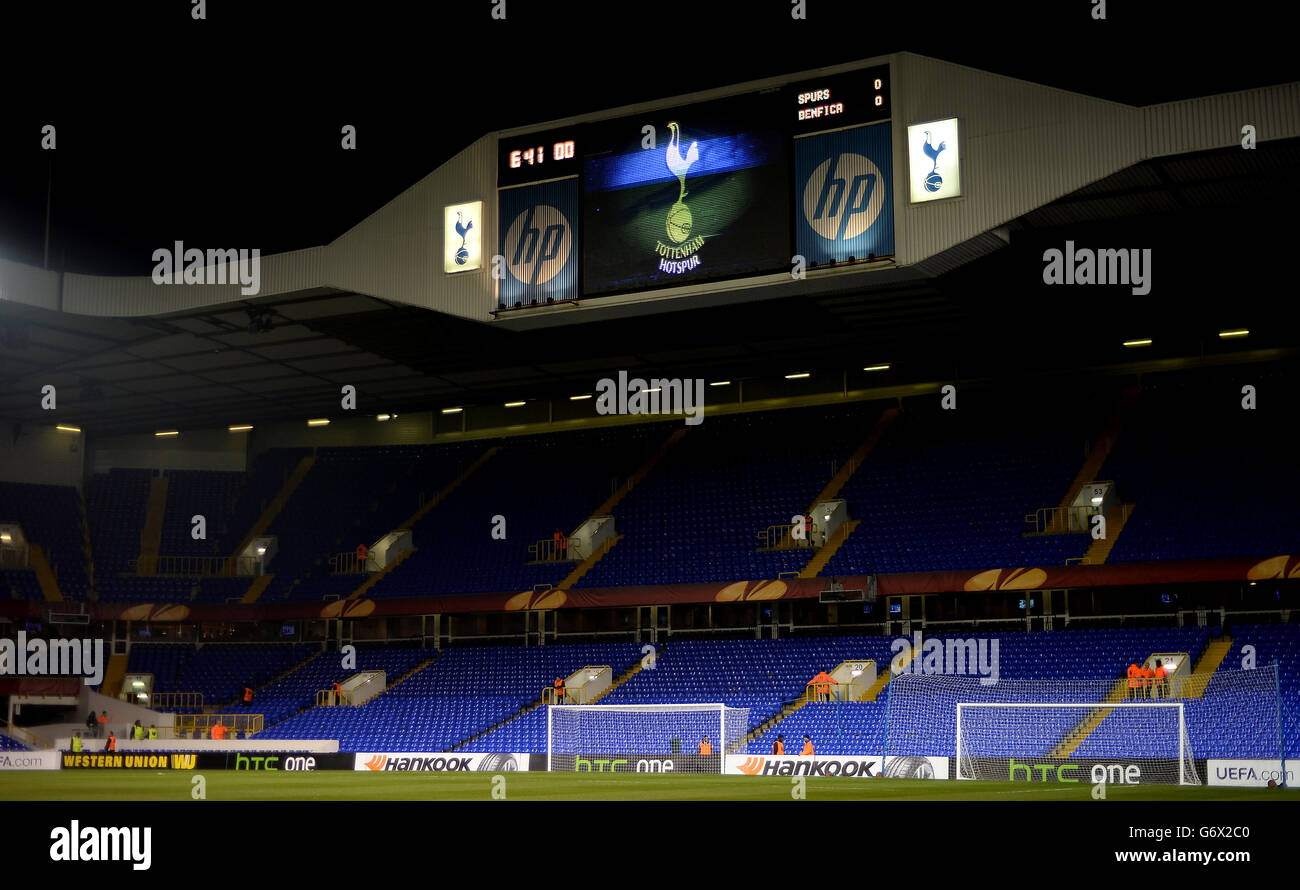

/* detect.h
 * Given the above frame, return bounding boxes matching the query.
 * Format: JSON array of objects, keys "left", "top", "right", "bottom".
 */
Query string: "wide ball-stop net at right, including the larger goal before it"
[{"left": 884, "top": 665, "right": 1281, "bottom": 785}]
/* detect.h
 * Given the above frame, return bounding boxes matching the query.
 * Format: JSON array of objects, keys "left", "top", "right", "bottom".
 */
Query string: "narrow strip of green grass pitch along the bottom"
[{"left": 0, "top": 770, "right": 1300, "bottom": 803}]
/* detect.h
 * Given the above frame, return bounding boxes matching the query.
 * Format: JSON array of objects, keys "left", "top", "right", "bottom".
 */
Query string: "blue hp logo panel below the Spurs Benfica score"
[{"left": 794, "top": 123, "right": 894, "bottom": 265}]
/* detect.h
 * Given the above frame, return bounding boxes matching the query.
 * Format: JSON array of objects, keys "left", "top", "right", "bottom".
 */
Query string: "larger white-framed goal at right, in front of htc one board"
[{"left": 956, "top": 702, "right": 1201, "bottom": 785}]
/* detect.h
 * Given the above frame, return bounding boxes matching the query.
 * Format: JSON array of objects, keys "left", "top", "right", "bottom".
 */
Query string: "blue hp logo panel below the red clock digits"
[{"left": 497, "top": 178, "right": 579, "bottom": 307}]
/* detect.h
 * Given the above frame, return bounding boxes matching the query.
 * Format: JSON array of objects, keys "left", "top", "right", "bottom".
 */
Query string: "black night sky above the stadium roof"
[{"left": 0, "top": 0, "right": 1300, "bottom": 274}]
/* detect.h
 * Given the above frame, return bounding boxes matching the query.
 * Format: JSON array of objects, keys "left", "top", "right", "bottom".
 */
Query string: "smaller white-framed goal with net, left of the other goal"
[{"left": 546, "top": 704, "right": 749, "bottom": 773}]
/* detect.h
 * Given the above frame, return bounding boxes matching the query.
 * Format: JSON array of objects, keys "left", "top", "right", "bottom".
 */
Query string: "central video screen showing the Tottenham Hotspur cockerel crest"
[{"left": 582, "top": 92, "right": 790, "bottom": 296}]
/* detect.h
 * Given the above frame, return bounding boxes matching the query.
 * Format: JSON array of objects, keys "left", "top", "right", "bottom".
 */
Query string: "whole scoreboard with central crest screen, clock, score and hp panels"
[{"left": 497, "top": 65, "right": 893, "bottom": 308}]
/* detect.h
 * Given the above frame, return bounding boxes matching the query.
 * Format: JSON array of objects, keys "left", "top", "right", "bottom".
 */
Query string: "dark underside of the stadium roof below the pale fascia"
[{"left": 0, "top": 133, "right": 1300, "bottom": 431}]
